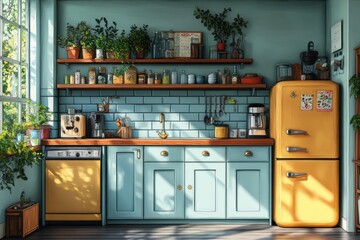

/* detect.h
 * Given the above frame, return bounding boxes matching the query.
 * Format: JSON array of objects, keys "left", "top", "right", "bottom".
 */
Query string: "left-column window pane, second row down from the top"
[{"left": 2, "top": 23, "right": 19, "bottom": 60}]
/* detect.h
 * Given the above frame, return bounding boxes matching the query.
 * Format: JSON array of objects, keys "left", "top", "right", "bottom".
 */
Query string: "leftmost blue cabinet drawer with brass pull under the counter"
[{"left": 144, "top": 146, "right": 184, "bottom": 162}]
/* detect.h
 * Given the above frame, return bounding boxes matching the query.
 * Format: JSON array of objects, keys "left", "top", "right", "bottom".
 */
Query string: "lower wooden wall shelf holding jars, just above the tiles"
[{"left": 56, "top": 83, "right": 266, "bottom": 90}]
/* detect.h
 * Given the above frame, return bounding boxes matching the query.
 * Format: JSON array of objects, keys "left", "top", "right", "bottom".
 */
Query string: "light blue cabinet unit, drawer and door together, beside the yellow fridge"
[{"left": 226, "top": 146, "right": 271, "bottom": 219}]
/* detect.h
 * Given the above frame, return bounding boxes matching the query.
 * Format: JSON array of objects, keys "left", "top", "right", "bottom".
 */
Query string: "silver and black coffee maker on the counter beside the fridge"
[{"left": 247, "top": 103, "right": 267, "bottom": 138}]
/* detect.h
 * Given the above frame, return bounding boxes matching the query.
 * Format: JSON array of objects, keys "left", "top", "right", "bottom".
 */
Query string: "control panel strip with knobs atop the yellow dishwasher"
[{"left": 46, "top": 148, "right": 101, "bottom": 159}]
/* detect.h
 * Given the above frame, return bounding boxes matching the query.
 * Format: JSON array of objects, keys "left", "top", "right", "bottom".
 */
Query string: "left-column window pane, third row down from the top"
[{"left": 2, "top": 61, "right": 19, "bottom": 97}]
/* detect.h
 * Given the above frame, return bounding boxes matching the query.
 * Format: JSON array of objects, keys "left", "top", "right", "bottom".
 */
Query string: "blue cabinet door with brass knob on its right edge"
[{"left": 144, "top": 163, "right": 184, "bottom": 219}]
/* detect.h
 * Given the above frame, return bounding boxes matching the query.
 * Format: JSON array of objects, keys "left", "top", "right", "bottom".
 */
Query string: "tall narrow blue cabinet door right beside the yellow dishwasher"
[{"left": 107, "top": 146, "right": 143, "bottom": 219}]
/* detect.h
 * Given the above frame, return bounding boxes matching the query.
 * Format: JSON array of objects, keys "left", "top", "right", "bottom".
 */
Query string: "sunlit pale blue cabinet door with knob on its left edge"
[{"left": 185, "top": 162, "right": 225, "bottom": 219}]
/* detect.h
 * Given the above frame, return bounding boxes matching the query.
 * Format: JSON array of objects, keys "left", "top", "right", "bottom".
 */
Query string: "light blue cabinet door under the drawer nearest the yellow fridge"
[{"left": 227, "top": 162, "right": 270, "bottom": 219}]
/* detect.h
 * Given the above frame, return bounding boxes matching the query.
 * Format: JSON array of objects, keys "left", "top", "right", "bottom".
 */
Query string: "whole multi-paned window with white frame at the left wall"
[{"left": 0, "top": 0, "right": 30, "bottom": 132}]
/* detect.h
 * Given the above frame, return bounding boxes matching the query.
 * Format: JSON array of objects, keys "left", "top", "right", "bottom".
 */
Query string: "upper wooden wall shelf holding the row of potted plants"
[{"left": 57, "top": 58, "right": 253, "bottom": 64}]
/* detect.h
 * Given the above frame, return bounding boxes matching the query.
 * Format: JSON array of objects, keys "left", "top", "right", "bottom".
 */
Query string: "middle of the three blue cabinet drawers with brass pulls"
[{"left": 185, "top": 146, "right": 225, "bottom": 162}]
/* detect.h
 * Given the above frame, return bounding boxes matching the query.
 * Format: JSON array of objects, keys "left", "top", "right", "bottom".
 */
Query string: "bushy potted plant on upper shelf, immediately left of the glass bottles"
[{"left": 129, "top": 24, "right": 151, "bottom": 58}]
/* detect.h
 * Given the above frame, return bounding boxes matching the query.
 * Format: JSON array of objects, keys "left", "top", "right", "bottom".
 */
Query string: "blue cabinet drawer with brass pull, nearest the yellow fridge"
[{"left": 226, "top": 146, "right": 271, "bottom": 162}]
